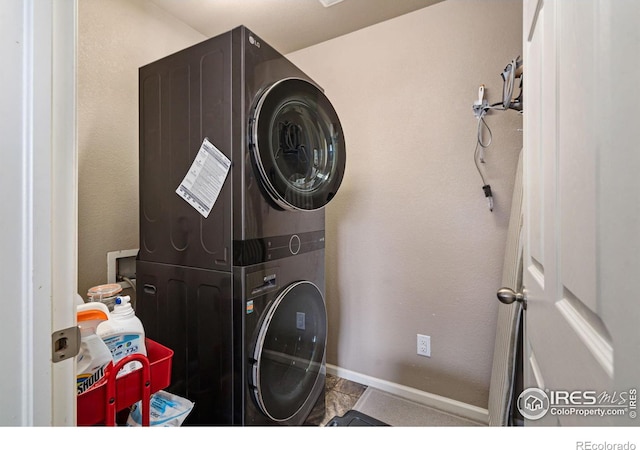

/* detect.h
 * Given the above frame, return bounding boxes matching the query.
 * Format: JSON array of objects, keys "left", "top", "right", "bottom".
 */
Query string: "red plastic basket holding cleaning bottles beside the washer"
[{"left": 77, "top": 338, "right": 173, "bottom": 426}]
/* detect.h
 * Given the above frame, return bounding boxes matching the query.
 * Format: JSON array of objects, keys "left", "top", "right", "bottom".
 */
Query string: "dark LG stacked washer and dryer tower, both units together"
[{"left": 136, "top": 27, "right": 345, "bottom": 425}]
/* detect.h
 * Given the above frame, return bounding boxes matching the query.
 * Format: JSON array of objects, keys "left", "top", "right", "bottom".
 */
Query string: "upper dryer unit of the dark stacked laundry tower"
[{"left": 139, "top": 27, "right": 346, "bottom": 271}]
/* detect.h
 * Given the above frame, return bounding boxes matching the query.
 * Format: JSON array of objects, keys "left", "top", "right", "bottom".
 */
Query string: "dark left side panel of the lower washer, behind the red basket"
[{"left": 136, "top": 261, "right": 234, "bottom": 425}]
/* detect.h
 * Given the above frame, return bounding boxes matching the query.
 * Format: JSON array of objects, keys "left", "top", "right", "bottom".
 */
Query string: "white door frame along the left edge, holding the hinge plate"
[{"left": 0, "top": 0, "right": 77, "bottom": 426}]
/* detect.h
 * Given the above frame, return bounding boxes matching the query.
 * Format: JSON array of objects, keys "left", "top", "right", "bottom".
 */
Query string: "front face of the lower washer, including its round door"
[{"left": 236, "top": 250, "right": 327, "bottom": 425}]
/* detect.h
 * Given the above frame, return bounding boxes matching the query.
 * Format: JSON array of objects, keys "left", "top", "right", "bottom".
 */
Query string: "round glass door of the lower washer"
[{"left": 251, "top": 281, "right": 327, "bottom": 422}]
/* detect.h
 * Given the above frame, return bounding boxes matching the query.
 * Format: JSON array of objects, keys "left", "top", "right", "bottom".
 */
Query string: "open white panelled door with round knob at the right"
[{"left": 519, "top": 0, "right": 640, "bottom": 426}]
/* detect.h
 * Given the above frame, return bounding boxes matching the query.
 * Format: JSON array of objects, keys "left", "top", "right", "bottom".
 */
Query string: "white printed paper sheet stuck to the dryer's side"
[{"left": 176, "top": 138, "right": 231, "bottom": 218}]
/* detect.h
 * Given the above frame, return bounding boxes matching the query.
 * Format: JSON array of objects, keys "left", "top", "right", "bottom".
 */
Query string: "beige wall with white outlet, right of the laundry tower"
[{"left": 288, "top": 0, "right": 522, "bottom": 408}]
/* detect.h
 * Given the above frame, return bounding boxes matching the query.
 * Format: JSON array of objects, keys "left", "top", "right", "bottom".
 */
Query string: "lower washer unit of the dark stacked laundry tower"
[{"left": 136, "top": 245, "right": 327, "bottom": 426}]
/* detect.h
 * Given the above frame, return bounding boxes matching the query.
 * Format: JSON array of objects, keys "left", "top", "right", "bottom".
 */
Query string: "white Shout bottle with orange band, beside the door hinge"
[{"left": 76, "top": 303, "right": 113, "bottom": 395}]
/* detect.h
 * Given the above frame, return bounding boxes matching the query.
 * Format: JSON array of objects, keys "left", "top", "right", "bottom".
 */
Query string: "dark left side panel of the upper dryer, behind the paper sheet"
[{"left": 139, "top": 34, "right": 233, "bottom": 270}]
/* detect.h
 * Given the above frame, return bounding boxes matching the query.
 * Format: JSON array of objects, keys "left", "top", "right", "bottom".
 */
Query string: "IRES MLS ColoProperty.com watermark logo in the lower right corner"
[{"left": 517, "top": 388, "right": 637, "bottom": 420}]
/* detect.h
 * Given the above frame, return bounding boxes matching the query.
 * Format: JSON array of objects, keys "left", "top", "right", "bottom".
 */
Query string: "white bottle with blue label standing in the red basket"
[{"left": 97, "top": 295, "right": 147, "bottom": 377}]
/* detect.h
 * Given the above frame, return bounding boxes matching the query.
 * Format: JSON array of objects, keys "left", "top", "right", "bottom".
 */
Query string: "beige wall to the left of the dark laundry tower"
[{"left": 77, "top": 0, "right": 206, "bottom": 297}]
